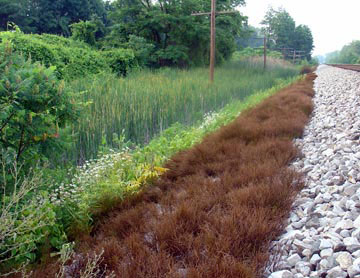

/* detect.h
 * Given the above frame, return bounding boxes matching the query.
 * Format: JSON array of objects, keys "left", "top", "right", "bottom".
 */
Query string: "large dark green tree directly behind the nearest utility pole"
[{"left": 106, "top": 0, "right": 245, "bottom": 66}]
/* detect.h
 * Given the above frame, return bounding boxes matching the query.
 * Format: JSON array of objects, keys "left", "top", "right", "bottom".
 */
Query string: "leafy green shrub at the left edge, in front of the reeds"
[{"left": 0, "top": 41, "right": 78, "bottom": 164}]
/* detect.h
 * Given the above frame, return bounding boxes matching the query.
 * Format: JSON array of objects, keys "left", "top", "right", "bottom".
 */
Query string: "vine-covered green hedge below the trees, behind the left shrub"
[{"left": 0, "top": 32, "right": 138, "bottom": 80}]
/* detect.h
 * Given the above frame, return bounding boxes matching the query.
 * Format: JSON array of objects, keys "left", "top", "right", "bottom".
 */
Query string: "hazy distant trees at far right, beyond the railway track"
[{"left": 326, "top": 41, "right": 360, "bottom": 64}]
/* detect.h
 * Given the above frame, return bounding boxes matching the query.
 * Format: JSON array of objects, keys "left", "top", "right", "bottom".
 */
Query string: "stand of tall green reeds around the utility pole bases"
[{"left": 71, "top": 59, "right": 297, "bottom": 161}]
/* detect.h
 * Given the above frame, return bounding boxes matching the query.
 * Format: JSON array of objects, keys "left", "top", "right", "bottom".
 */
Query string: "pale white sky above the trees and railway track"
[{"left": 239, "top": 0, "right": 360, "bottom": 55}]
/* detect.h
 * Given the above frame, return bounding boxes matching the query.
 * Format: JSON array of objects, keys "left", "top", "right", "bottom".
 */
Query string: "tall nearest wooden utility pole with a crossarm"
[{"left": 191, "top": 0, "right": 237, "bottom": 83}]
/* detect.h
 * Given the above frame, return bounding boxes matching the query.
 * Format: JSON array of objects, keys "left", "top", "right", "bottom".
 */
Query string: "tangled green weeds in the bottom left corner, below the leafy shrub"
[{"left": 0, "top": 156, "right": 67, "bottom": 274}]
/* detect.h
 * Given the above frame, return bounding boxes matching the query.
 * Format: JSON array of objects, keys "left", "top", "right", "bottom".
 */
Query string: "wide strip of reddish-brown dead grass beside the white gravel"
[{"left": 34, "top": 74, "right": 315, "bottom": 278}]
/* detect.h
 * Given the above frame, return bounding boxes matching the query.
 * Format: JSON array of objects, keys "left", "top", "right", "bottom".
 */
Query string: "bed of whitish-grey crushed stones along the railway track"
[{"left": 265, "top": 66, "right": 360, "bottom": 278}]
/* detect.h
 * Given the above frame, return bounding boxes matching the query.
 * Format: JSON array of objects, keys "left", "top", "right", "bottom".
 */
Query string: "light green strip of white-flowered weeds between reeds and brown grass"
[{"left": 58, "top": 73, "right": 297, "bottom": 230}]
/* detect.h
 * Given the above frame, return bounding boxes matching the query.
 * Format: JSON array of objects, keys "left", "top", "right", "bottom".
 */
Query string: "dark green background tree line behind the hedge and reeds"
[{"left": 0, "top": 0, "right": 313, "bottom": 67}]
